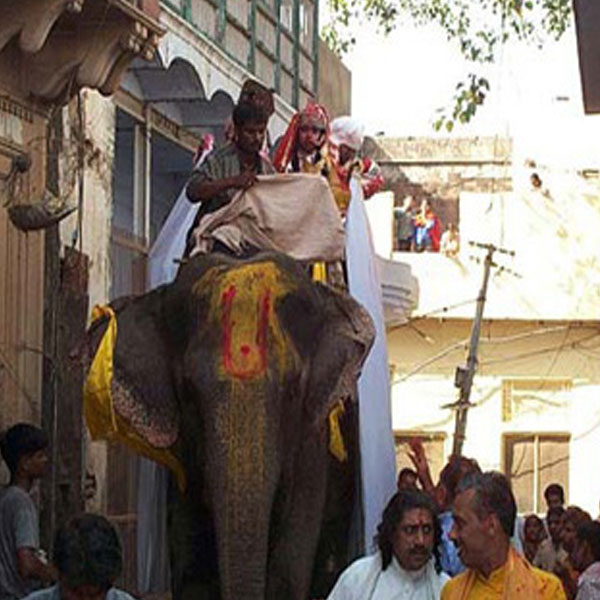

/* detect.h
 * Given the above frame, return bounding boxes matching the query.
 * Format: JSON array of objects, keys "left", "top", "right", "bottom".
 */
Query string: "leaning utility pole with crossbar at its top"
[{"left": 452, "top": 242, "right": 515, "bottom": 454}]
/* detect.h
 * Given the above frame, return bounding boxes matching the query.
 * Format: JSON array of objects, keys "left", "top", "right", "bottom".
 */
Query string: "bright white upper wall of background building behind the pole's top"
[{"left": 377, "top": 152, "right": 600, "bottom": 320}]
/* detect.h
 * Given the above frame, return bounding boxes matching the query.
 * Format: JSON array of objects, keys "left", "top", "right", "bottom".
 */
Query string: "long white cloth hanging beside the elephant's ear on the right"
[{"left": 346, "top": 178, "right": 396, "bottom": 551}]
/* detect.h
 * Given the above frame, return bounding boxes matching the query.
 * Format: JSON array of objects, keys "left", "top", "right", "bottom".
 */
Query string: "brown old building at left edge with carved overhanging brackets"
[{"left": 0, "top": 0, "right": 165, "bottom": 543}]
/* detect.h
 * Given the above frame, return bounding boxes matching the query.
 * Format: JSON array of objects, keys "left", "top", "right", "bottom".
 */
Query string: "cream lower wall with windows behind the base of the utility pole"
[{"left": 388, "top": 318, "right": 600, "bottom": 516}]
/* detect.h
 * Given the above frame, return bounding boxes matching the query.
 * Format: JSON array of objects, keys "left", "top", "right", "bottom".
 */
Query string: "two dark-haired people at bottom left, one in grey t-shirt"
[{"left": 0, "top": 423, "right": 133, "bottom": 600}]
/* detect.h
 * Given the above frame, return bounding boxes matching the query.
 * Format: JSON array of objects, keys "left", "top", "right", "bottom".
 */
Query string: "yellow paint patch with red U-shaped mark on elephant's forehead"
[{"left": 194, "top": 261, "right": 295, "bottom": 380}]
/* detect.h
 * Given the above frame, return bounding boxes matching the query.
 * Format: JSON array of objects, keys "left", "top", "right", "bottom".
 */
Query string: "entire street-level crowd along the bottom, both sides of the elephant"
[{"left": 0, "top": 423, "right": 600, "bottom": 600}]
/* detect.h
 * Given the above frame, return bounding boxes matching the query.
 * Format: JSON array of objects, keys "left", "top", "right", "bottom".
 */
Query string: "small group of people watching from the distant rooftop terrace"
[{"left": 394, "top": 196, "right": 460, "bottom": 257}]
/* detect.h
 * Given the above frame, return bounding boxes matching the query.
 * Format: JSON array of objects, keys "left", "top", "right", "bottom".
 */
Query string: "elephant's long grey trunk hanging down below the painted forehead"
[{"left": 207, "top": 382, "right": 279, "bottom": 600}]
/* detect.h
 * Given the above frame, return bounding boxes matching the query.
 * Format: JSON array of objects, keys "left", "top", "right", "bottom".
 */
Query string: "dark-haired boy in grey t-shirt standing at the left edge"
[{"left": 0, "top": 423, "right": 55, "bottom": 600}]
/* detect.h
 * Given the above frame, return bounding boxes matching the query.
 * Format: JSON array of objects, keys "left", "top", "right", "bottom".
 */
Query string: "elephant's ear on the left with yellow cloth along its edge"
[{"left": 84, "top": 288, "right": 179, "bottom": 454}]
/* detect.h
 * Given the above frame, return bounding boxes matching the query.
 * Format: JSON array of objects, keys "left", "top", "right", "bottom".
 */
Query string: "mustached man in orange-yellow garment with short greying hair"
[{"left": 442, "top": 471, "right": 565, "bottom": 600}]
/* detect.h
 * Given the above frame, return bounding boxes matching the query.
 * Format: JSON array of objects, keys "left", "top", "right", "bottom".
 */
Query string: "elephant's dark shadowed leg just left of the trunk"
[{"left": 168, "top": 482, "right": 220, "bottom": 600}]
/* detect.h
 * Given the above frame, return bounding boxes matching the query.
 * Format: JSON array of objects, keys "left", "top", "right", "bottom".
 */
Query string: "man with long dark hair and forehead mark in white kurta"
[{"left": 328, "top": 490, "right": 448, "bottom": 600}]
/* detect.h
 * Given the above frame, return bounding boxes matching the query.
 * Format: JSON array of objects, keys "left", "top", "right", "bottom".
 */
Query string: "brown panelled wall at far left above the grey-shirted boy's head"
[{"left": 0, "top": 98, "right": 46, "bottom": 430}]
